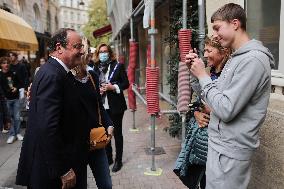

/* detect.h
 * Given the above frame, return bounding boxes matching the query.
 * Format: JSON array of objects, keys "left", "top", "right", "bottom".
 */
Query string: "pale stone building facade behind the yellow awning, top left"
[{"left": 0, "top": 0, "right": 59, "bottom": 59}]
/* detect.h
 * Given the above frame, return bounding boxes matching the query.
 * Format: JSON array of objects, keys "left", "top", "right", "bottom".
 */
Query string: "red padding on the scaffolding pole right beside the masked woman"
[{"left": 127, "top": 41, "right": 138, "bottom": 110}]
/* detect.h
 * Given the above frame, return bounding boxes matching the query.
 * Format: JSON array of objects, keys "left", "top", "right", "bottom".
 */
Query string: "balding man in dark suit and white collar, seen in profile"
[{"left": 16, "top": 29, "right": 86, "bottom": 189}]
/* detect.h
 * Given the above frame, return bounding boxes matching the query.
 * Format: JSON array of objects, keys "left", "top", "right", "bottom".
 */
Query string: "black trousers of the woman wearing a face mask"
[{"left": 106, "top": 110, "right": 124, "bottom": 162}]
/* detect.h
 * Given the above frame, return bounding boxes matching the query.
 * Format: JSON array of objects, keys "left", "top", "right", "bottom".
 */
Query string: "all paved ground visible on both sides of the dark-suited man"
[{"left": 0, "top": 104, "right": 186, "bottom": 189}]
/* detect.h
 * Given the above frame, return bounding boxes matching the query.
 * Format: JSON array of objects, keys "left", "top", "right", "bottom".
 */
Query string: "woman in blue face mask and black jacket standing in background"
[{"left": 94, "top": 43, "right": 129, "bottom": 172}]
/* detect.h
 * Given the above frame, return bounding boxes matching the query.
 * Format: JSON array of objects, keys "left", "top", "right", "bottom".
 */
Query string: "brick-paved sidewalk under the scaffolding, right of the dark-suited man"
[{"left": 88, "top": 104, "right": 186, "bottom": 189}]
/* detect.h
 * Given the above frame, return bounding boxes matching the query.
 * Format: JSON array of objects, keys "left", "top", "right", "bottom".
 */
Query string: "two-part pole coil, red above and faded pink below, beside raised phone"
[{"left": 177, "top": 29, "right": 192, "bottom": 112}]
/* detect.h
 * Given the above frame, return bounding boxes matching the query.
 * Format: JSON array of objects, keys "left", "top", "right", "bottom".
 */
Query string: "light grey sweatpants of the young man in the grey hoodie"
[{"left": 206, "top": 145, "right": 251, "bottom": 189}]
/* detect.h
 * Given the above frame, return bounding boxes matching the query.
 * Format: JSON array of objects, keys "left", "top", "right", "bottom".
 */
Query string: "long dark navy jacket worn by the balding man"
[{"left": 16, "top": 58, "right": 93, "bottom": 189}]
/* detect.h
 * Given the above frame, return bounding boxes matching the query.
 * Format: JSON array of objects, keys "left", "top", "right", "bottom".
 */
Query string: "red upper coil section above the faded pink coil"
[{"left": 178, "top": 29, "right": 192, "bottom": 62}]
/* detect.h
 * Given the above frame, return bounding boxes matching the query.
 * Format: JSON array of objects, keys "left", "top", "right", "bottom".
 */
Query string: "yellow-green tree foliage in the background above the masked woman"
[{"left": 83, "top": 0, "right": 111, "bottom": 47}]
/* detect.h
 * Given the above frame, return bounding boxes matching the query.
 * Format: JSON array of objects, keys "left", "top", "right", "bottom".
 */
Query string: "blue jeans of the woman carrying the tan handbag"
[{"left": 89, "top": 149, "right": 112, "bottom": 189}]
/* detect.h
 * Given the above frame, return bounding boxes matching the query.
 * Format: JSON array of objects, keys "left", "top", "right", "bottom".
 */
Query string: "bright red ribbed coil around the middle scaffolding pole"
[{"left": 146, "top": 67, "right": 160, "bottom": 114}]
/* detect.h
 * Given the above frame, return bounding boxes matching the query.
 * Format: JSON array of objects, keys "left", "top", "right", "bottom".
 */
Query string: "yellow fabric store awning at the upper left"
[{"left": 0, "top": 9, "right": 38, "bottom": 51}]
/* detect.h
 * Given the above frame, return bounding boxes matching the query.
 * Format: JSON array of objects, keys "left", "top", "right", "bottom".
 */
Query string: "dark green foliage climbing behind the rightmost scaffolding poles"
[{"left": 165, "top": 0, "right": 198, "bottom": 137}]
